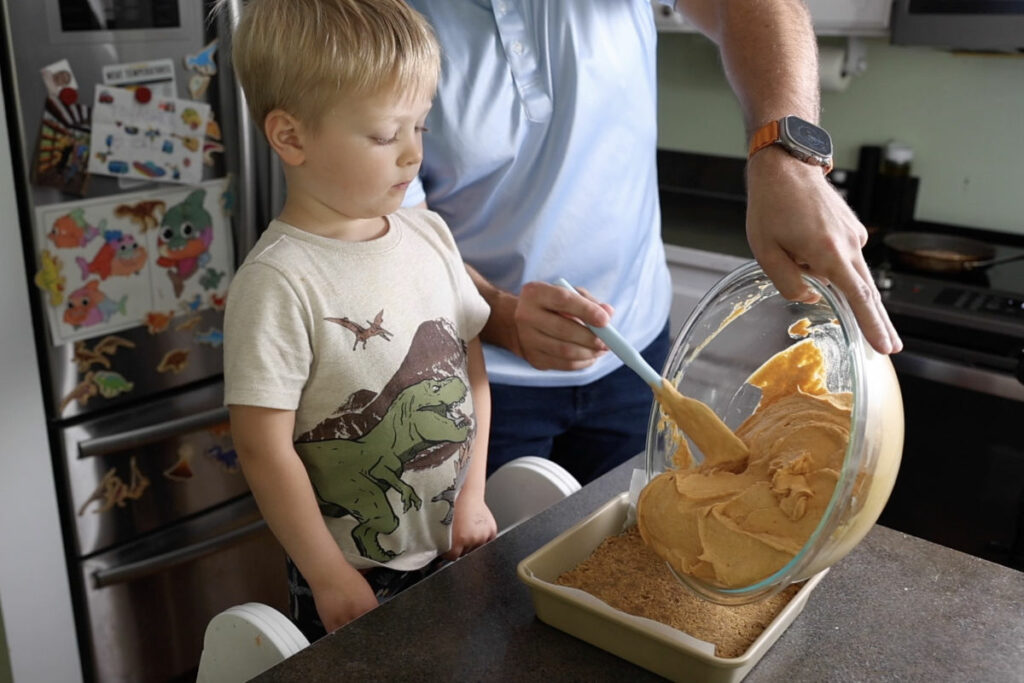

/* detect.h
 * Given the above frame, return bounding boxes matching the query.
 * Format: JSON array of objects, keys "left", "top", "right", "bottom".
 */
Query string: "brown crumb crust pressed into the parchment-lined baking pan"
[{"left": 558, "top": 526, "right": 801, "bottom": 657}]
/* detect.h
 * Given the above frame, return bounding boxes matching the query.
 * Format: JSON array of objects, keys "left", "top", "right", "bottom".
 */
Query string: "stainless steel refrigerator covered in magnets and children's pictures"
[{"left": 2, "top": 0, "right": 287, "bottom": 681}]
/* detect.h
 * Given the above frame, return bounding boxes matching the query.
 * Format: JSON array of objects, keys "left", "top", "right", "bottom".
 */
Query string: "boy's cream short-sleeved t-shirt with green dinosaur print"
[{"left": 224, "top": 209, "right": 489, "bottom": 570}]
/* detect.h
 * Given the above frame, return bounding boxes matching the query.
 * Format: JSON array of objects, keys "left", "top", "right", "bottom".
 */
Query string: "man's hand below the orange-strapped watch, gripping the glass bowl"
[{"left": 746, "top": 147, "right": 903, "bottom": 353}]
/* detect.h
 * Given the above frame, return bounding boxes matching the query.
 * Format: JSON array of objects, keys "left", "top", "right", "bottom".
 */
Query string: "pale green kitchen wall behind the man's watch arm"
[{"left": 658, "top": 33, "right": 1024, "bottom": 234}]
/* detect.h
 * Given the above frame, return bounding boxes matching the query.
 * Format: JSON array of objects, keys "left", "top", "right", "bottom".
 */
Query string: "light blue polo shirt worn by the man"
[{"left": 407, "top": 0, "right": 672, "bottom": 386}]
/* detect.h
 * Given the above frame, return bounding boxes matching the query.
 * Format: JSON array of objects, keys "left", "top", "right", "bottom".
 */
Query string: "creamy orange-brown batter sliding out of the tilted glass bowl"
[{"left": 637, "top": 331, "right": 852, "bottom": 588}]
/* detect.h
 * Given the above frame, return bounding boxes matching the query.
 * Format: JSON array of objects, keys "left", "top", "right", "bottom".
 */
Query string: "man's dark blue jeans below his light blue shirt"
[{"left": 487, "top": 325, "right": 671, "bottom": 484}]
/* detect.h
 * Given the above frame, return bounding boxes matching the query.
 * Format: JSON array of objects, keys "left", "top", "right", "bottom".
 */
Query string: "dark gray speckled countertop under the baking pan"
[{"left": 256, "top": 458, "right": 1024, "bottom": 683}]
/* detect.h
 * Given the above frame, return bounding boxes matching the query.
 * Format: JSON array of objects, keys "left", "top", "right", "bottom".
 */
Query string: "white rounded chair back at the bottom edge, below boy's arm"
[{"left": 197, "top": 602, "right": 309, "bottom": 683}]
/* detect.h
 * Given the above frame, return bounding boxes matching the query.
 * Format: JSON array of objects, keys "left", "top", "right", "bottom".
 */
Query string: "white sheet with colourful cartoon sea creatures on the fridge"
[{"left": 36, "top": 178, "right": 234, "bottom": 345}]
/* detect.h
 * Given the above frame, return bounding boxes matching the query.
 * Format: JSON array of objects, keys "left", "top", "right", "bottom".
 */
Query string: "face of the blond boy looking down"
[{"left": 289, "top": 86, "right": 431, "bottom": 219}]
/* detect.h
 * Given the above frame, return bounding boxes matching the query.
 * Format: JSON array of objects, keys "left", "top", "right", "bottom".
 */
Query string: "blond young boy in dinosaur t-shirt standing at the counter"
[{"left": 224, "top": 0, "right": 497, "bottom": 640}]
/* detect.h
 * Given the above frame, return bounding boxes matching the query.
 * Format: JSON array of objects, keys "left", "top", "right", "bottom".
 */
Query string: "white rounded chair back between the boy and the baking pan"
[{"left": 483, "top": 456, "right": 581, "bottom": 533}]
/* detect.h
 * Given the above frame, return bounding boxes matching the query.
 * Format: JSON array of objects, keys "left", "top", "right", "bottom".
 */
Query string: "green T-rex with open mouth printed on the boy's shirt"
[{"left": 295, "top": 377, "right": 470, "bottom": 562}]
